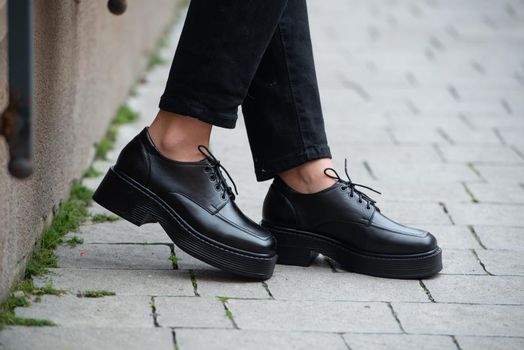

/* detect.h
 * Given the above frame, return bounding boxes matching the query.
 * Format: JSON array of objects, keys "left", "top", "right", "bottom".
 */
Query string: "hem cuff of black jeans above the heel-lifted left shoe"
[{"left": 158, "top": 95, "right": 238, "bottom": 129}]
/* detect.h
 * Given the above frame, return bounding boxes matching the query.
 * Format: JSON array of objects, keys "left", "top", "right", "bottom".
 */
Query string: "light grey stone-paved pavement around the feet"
[{"left": 0, "top": 0, "right": 524, "bottom": 350}]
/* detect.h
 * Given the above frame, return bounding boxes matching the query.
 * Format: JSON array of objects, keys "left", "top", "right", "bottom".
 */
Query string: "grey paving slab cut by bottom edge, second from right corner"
[{"left": 344, "top": 334, "right": 457, "bottom": 350}]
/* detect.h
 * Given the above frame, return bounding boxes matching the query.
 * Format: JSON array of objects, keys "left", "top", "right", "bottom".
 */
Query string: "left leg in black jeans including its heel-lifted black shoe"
[{"left": 94, "top": 0, "right": 296, "bottom": 279}]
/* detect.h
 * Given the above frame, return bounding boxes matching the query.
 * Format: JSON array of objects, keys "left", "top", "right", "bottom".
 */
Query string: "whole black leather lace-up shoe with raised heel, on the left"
[{"left": 93, "top": 128, "right": 277, "bottom": 279}]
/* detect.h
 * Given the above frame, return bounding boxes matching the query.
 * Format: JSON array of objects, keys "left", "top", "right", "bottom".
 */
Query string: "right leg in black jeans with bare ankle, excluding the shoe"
[{"left": 242, "top": 0, "right": 333, "bottom": 192}]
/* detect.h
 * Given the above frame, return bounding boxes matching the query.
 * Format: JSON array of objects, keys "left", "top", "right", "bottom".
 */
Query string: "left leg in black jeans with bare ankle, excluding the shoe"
[{"left": 150, "top": 0, "right": 287, "bottom": 160}]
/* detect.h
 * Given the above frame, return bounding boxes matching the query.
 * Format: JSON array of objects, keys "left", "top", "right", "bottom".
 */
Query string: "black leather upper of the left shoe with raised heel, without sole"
[{"left": 115, "top": 128, "right": 274, "bottom": 254}]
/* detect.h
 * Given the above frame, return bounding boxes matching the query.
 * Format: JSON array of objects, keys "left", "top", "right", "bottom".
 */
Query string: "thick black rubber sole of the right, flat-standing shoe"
[{"left": 261, "top": 221, "right": 442, "bottom": 279}]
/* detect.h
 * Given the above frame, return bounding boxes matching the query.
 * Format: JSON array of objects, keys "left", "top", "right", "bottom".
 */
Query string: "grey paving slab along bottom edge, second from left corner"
[{"left": 176, "top": 329, "right": 347, "bottom": 350}]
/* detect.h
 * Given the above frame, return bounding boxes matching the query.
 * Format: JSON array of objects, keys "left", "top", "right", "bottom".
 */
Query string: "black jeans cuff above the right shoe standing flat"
[{"left": 255, "top": 144, "right": 331, "bottom": 181}]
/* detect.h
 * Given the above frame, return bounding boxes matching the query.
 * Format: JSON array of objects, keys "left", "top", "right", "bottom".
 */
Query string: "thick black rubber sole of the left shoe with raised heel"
[{"left": 93, "top": 168, "right": 277, "bottom": 280}]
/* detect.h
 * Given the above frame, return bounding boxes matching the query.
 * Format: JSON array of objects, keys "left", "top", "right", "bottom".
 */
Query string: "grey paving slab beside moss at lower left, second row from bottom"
[{"left": 15, "top": 295, "right": 154, "bottom": 328}]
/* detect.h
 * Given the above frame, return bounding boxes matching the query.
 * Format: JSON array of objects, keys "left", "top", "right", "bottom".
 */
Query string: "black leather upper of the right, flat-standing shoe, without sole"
[{"left": 262, "top": 177, "right": 437, "bottom": 254}]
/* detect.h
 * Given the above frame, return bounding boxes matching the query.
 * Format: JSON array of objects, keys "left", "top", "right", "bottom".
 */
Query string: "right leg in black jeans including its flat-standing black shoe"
[{"left": 236, "top": 0, "right": 442, "bottom": 278}]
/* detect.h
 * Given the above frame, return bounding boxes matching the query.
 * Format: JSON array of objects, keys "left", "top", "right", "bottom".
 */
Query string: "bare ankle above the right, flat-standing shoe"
[{"left": 278, "top": 158, "right": 335, "bottom": 193}]
